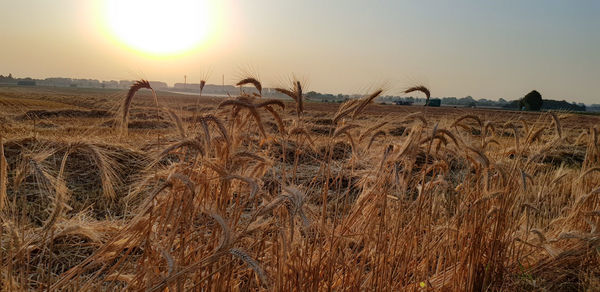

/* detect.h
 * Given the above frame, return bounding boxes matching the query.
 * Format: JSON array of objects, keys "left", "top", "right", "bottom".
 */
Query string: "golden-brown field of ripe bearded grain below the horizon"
[{"left": 0, "top": 84, "right": 600, "bottom": 291}]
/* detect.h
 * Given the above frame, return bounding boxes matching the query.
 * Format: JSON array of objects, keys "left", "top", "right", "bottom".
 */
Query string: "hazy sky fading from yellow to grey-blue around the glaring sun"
[{"left": 0, "top": 0, "right": 600, "bottom": 104}]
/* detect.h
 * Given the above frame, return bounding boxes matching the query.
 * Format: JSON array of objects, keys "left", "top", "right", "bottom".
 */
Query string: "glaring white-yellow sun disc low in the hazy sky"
[{"left": 105, "top": 0, "right": 211, "bottom": 55}]
